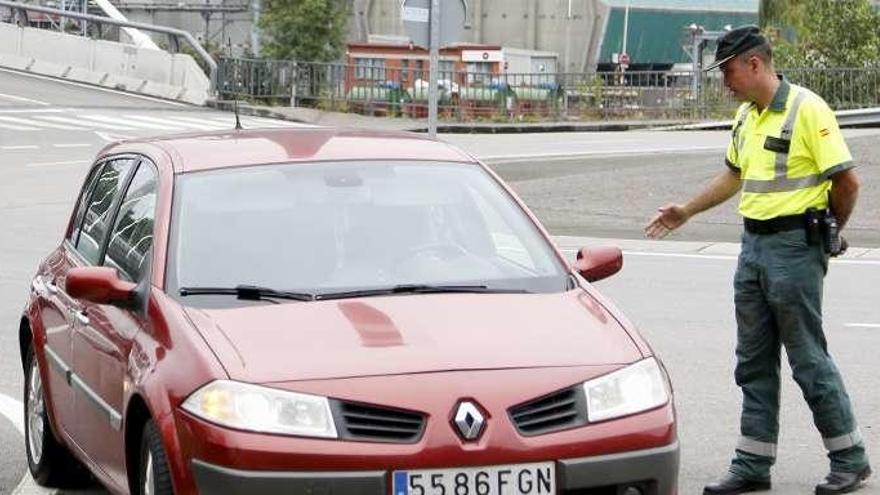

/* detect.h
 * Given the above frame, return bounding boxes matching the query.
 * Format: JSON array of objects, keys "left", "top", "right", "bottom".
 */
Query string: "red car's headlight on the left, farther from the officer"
[{"left": 181, "top": 380, "right": 338, "bottom": 438}]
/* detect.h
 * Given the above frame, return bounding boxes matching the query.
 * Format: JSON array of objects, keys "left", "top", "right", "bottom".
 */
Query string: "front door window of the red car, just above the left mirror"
[{"left": 104, "top": 160, "right": 158, "bottom": 282}]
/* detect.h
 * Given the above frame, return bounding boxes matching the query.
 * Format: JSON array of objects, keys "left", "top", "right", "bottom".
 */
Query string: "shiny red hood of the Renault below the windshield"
[{"left": 185, "top": 289, "right": 641, "bottom": 383}]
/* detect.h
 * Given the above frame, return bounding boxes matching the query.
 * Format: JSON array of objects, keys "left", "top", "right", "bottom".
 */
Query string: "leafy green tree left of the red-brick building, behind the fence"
[{"left": 260, "top": 0, "right": 349, "bottom": 62}]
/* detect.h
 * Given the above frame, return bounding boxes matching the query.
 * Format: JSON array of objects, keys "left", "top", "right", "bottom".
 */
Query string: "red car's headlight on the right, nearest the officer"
[{"left": 584, "top": 358, "right": 669, "bottom": 422}]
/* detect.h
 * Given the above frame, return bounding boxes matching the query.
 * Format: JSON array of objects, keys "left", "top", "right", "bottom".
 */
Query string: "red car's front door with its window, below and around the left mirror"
[{"left": 73, "top": 159, "right": 158, "bottom": 486}]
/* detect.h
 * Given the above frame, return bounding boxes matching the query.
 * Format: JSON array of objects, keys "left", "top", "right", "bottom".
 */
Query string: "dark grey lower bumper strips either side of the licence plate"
[{"left": 192, "top": 442, "right": 679, "bottom": 495}]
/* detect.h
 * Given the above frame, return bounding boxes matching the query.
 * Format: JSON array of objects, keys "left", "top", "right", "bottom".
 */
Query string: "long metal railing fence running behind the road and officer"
[{"left": 217, "top": 58, "right": 880, "bottom": 121}]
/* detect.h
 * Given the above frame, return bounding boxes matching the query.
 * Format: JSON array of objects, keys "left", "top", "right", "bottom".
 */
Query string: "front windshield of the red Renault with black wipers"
[{"left": 168, "top": 162, "right": 569, "bottom": 306}]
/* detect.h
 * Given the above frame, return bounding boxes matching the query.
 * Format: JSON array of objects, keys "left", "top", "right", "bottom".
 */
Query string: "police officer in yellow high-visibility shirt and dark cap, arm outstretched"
[{"left": 645, "top": 26, "right": 871, "bottom": 495}]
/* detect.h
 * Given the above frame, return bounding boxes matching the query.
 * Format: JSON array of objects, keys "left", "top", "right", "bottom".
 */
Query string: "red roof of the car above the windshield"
[{"left": 100, "top": 126, "right": 476, "bottom": 173}]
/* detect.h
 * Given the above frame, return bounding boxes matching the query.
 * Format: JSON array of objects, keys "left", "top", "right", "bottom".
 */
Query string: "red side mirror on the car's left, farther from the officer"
[{"left": 65, "top": 266, "right": 137, "bottom": 308}]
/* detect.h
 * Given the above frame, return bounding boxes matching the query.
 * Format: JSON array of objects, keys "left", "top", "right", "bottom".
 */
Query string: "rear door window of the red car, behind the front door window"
[{"left": 76, "top": 158, "right": 135, "bottom": 265}]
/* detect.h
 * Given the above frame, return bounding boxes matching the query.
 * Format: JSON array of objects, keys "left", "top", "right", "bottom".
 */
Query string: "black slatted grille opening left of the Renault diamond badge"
[{"left": 331, "top": 401, "right": 425, "bottom": 443}]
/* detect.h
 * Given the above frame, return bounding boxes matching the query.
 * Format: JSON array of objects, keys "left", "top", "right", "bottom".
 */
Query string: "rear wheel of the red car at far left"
[{"left": 24, "top": 346, "right": 92, "bottom": 488}]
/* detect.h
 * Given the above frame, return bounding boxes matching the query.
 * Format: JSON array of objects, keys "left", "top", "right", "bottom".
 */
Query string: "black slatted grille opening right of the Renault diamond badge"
[{"left": 509, "top": 387, "right": 587, "bottom": 436}]
